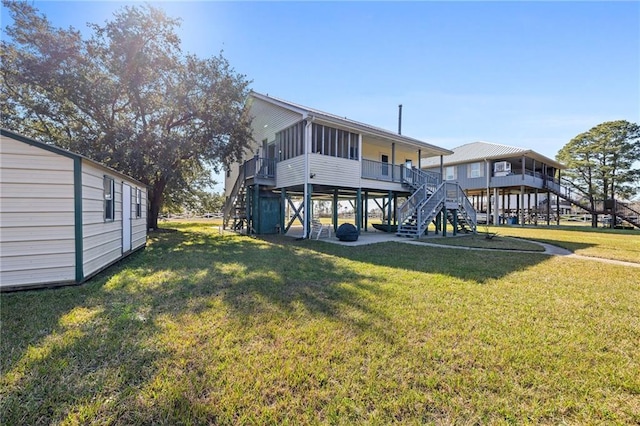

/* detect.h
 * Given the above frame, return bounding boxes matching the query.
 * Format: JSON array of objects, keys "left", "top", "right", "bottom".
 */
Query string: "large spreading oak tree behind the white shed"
[{"left": 0, "top": 1, "right": 251, "bottom": 228}]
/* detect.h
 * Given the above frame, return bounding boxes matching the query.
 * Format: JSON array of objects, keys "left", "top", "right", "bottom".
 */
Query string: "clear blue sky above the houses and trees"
[{"left": 2, "top": 1, "right": 640, "bottom": 190}]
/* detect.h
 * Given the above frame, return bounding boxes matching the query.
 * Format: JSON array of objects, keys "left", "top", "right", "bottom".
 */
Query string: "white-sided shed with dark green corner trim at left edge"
[{"left": 0, "top": 129, "right": 147, "bottom": 291}]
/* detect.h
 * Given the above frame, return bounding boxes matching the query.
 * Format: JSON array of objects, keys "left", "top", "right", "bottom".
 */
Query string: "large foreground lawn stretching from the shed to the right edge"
[{"left": 0, "top": 223, "right": 640, "bottom": 425}]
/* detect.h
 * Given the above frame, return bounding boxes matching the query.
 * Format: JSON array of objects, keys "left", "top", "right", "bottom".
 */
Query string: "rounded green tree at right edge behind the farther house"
[{"left": 556, "top": 120, "right": 640, "bottom": 203}]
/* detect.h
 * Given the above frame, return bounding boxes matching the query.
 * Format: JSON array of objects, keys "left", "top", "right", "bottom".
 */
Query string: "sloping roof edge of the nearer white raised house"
[{"left": 249, "top": 91, "right": 453, "bottom": 156}]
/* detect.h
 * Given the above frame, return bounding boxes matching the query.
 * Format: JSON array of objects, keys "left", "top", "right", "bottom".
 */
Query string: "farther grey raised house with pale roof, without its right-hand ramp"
[{"left": 423, "top": 142, "right": 564, "bottom": 224}]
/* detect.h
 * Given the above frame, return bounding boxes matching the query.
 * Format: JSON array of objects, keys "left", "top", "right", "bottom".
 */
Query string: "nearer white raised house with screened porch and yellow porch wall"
[{"left": 224, "top": 92, "right": 475, "bottom": 238}]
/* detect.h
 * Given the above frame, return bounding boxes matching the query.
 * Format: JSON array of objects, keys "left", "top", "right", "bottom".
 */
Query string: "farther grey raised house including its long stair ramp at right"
[{"left": 422, "top": 142, "right": 640, "bottom": 228}]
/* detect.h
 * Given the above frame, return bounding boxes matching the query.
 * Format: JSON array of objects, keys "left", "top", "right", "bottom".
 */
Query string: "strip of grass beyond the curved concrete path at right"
[{"left": 478, "top": 226, "right": 640, "bottom": 263}]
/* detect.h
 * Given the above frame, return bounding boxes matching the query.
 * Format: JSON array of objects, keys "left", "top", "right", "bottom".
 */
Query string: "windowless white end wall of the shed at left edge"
[{"left": 0, "top": 136, "right": 75, "bottom": 287}]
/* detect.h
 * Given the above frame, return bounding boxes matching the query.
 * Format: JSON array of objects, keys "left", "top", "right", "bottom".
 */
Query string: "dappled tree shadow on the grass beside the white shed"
[{"left": 0, "top": 226, "right": 395, "bottom": 424}]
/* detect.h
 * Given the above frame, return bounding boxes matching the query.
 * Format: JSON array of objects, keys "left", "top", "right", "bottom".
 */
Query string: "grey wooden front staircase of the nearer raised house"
[{"left": 396, "top": 169, "right": 476, "bottom": 238}]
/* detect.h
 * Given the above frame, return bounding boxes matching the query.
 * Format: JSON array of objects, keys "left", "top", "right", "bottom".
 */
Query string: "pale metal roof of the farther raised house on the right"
[{"left": 422, "top": 142, "right": 565, "bottom": 169}]
